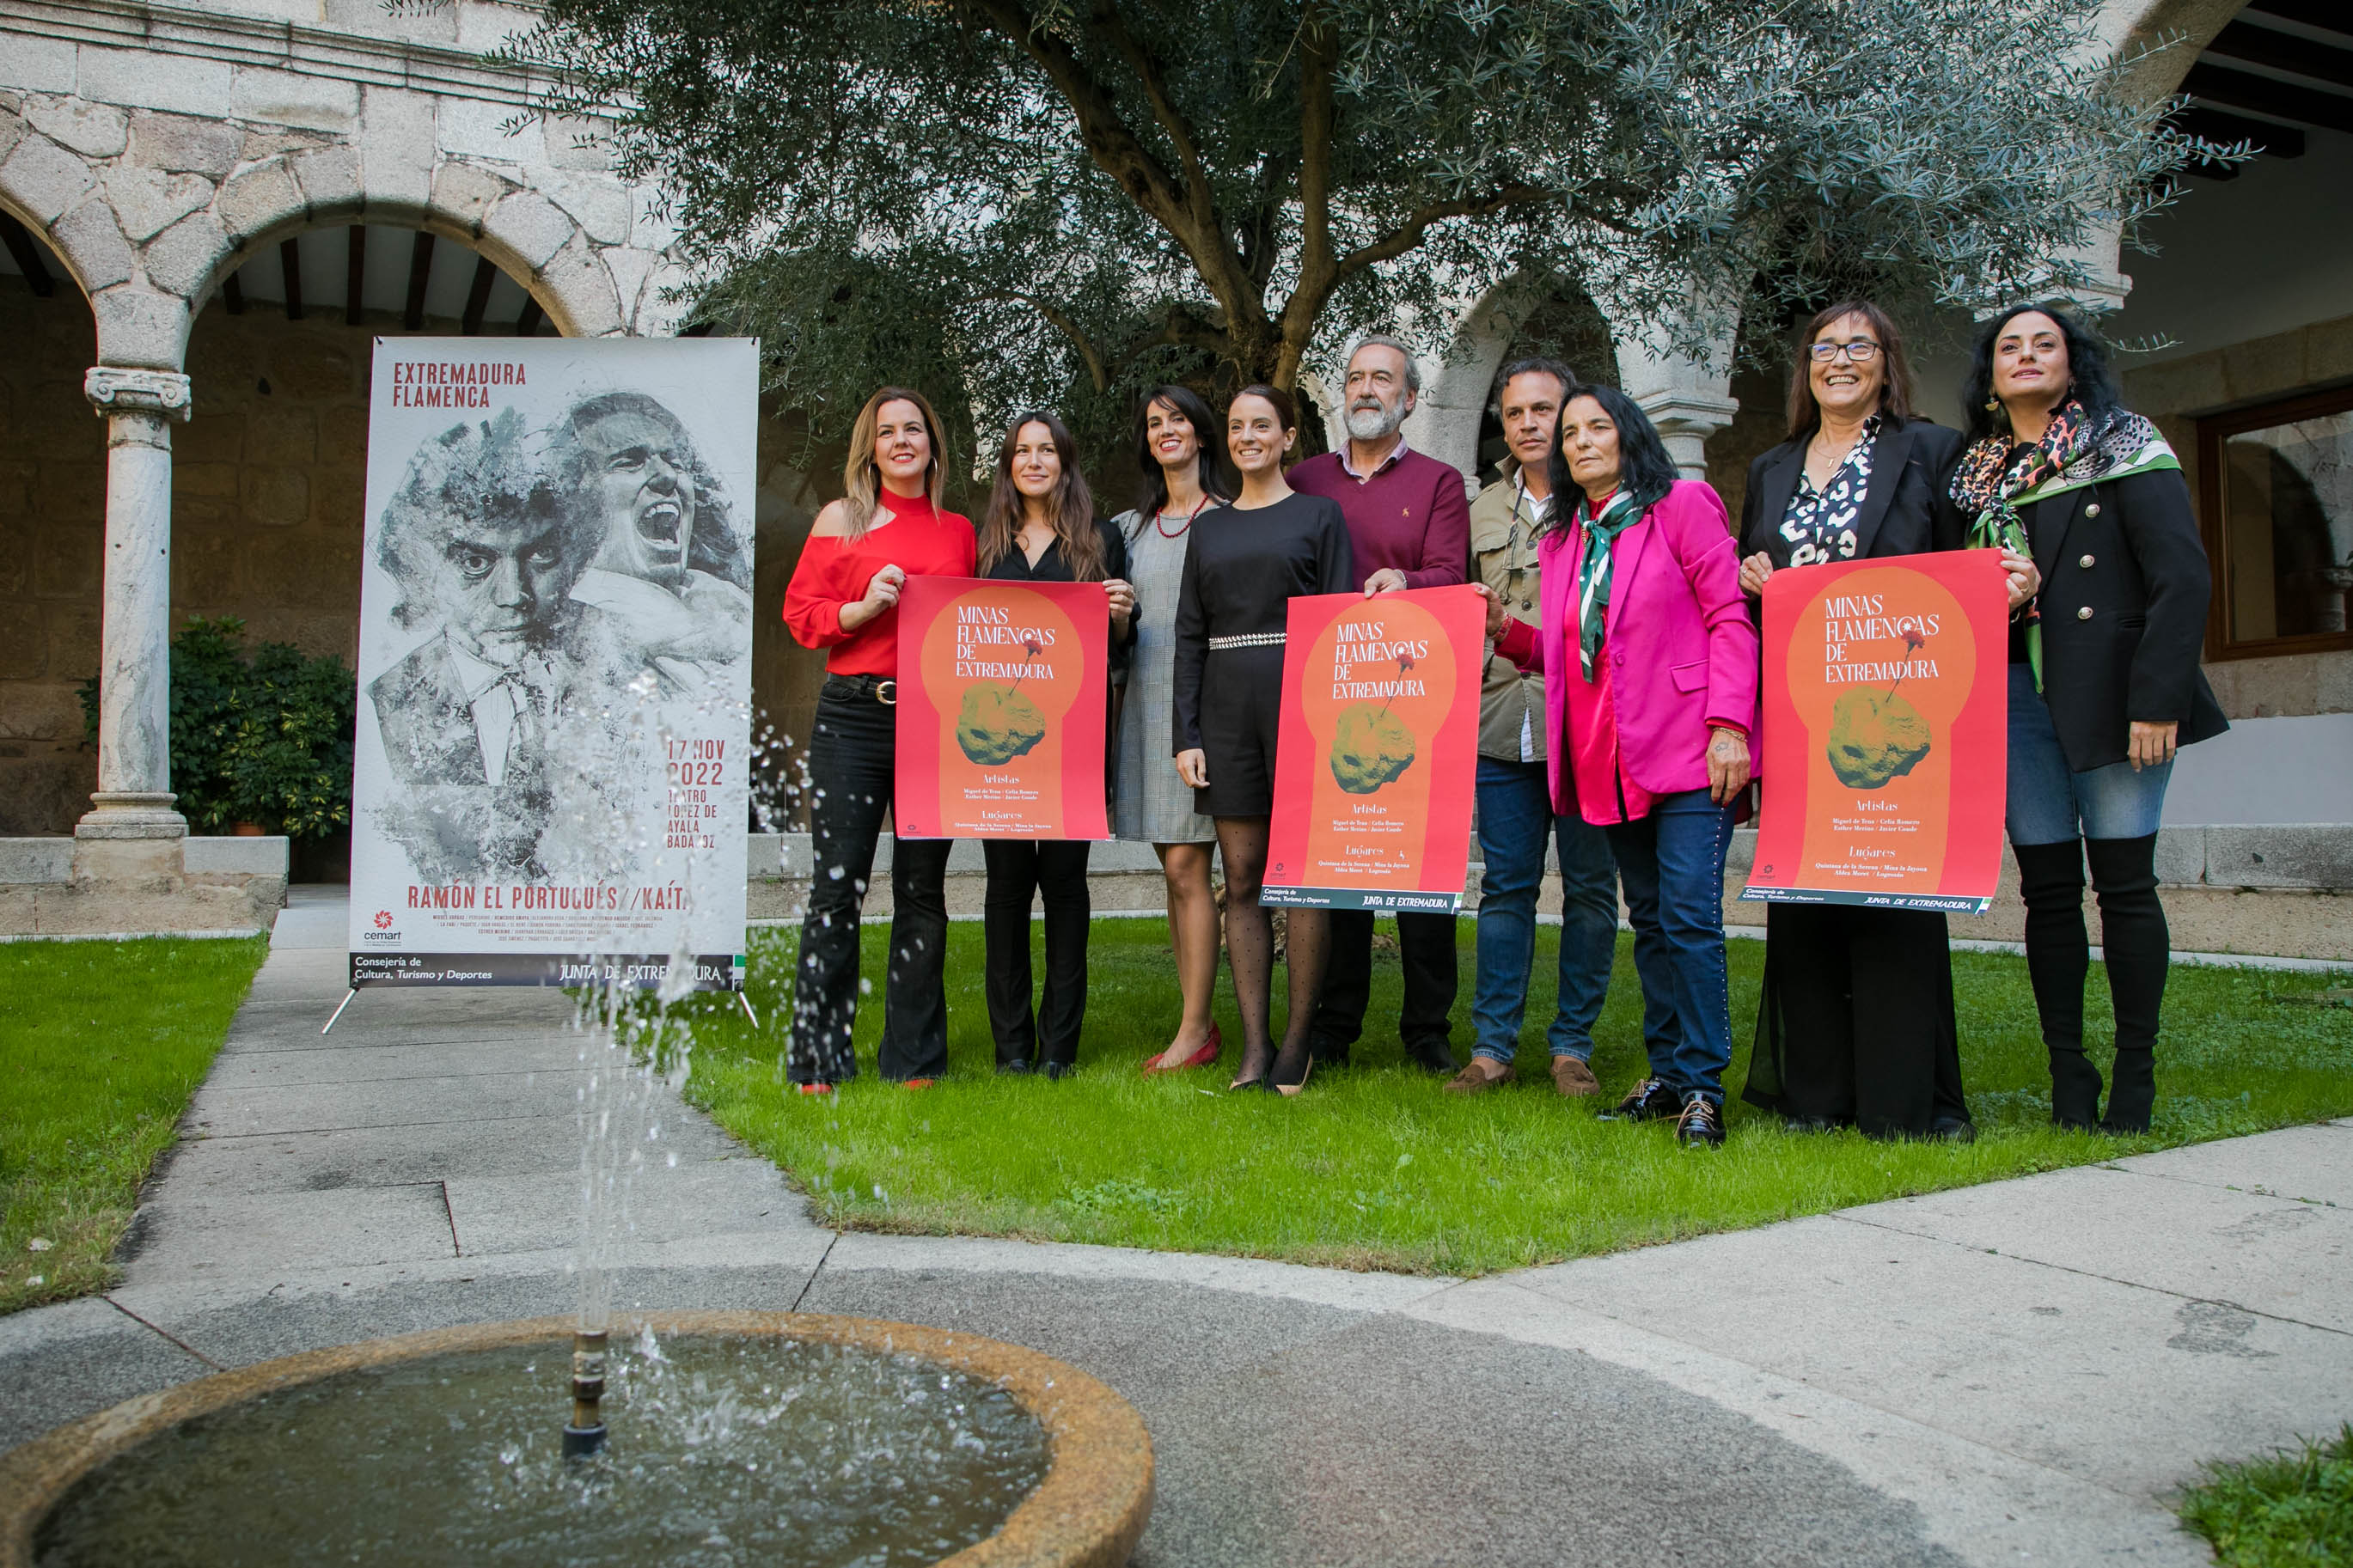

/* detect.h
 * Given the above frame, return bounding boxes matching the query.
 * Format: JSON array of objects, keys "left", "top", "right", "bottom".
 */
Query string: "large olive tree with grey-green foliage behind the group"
[{"left": 516, "top": 0, "right": 2196, "bottom": 442}]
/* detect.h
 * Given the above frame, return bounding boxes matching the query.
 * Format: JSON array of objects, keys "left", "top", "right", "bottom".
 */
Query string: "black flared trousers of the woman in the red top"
[{"left": 785, "top": 677, "right": 950, "bottom": 1083}]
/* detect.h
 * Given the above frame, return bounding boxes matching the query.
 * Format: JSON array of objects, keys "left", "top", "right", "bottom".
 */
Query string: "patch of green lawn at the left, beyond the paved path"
[{"left": 0, "top": 936, "right": 268, "bottom": 1312}]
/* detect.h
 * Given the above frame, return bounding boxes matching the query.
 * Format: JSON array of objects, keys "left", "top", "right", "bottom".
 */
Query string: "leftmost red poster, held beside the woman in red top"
[{"left": 892, "top": 576, "right": 1110, "bottom": 839}]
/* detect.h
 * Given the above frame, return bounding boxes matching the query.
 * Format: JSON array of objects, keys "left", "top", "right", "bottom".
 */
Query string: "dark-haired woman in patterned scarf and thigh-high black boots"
[{"left": 1951, "top": 303, "right": 2228, "bottom": 1133}]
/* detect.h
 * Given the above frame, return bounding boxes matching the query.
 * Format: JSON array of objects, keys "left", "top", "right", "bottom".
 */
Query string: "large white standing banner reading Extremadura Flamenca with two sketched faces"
[{"left": 351, "top": 339, "right": 758, "bottom": 990}]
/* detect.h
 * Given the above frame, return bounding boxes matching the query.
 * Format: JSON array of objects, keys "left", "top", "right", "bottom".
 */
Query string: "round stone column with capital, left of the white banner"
[{"left": 73, "top": 364, "right": 188, "bottom": 860}]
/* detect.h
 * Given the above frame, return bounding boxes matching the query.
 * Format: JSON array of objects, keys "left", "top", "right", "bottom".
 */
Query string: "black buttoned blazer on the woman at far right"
[{"left": 2021, "top": 467, "right": 2231, "bottom": 773}]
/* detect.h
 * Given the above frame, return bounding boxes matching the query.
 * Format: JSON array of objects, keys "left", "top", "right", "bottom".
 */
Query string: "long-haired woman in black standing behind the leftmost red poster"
[{"left": 979, "top": 414, "right": 1136, "bottom": 1079}]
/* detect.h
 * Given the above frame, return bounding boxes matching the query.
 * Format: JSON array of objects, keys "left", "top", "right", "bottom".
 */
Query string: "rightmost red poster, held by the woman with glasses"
[{"left": 1741, "top": 550, "right": 2009, "bottom": 914}]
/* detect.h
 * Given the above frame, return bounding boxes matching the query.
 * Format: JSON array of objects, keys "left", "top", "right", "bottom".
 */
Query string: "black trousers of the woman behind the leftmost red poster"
[{"left": 981, "top": 839, "right": 1091, "bottom": 1067}]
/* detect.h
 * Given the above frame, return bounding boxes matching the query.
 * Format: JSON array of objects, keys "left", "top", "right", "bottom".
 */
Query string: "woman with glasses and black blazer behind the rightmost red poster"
[{"left": 1741, "top": 301, "right": 2033, "bottom": 1143}]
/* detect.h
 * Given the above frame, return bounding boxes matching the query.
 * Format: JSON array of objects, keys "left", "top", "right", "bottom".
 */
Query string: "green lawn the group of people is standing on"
[{"left": 685, "top": 919, "right": 2353, "bottom": 1274}]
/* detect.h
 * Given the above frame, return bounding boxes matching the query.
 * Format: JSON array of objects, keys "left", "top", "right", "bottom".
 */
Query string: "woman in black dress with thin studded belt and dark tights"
[{"left": 1172, "top": 386, "right": 1355, "bottom": 1095}]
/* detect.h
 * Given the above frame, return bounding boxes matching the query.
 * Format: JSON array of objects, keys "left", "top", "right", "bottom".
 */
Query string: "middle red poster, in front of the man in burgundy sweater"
[{"left": 1259, "top": 588, "right": 1487, "bottom": 912}]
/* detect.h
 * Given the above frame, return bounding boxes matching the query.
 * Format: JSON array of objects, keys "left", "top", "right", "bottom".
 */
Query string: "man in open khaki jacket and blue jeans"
[{"left": 1447, "top": 360, "right": 1617, "bottom": 1098}]
